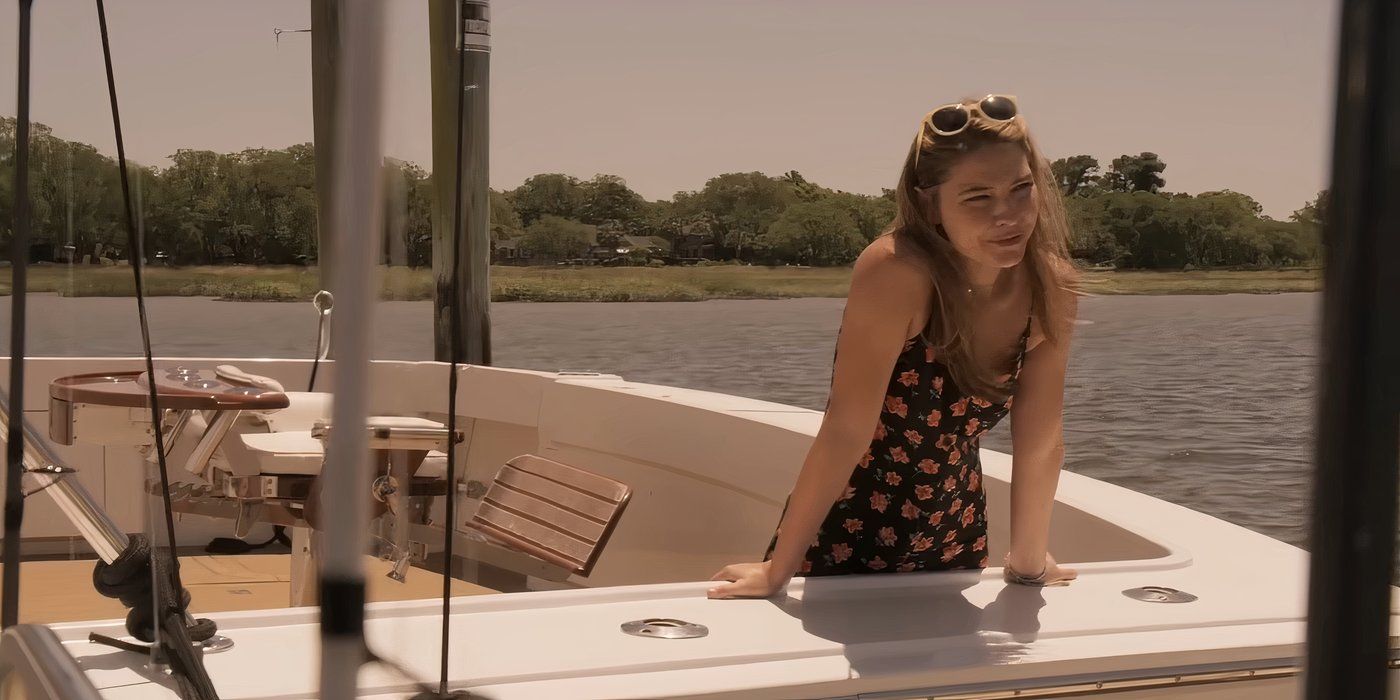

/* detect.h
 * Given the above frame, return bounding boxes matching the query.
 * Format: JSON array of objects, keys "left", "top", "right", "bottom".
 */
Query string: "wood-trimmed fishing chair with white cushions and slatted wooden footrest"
[{"left": 49, "top": 364, "right": 630, "bottom": 605}]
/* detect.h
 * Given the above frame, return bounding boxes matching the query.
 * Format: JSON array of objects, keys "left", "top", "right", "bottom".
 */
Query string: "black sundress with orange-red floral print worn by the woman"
[{"left": 763, "top": 319, "right": 1030, "bottom": 575}]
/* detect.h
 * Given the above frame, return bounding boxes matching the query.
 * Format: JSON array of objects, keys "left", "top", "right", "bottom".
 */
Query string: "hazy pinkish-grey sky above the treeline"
[{"left": 0, "top": 0, "right": 1337, "bottom": 217}]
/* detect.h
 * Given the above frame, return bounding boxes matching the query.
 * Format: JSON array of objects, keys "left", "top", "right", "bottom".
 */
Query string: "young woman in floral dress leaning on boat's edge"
[{"left": 708, "top": 95, "right": 1077, "bottom": 598}]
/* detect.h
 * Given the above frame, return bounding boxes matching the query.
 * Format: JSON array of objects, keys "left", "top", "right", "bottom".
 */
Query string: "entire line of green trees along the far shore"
[{"left": 0, "top": 119, "right": 1326, "bottom": 269}]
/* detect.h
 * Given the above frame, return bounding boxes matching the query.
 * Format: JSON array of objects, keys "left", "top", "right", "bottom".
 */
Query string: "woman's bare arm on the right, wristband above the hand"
[{"left": 1007, "top": 297, "right": 1077, "bottom": 575}]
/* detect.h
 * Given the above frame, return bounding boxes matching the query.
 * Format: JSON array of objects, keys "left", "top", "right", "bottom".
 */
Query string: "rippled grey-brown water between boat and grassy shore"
[{"left": 0, "top": 294, "right": 1320, "bottom": 557}]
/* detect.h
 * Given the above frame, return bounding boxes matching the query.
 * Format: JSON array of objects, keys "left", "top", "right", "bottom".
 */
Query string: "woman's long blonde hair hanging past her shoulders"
[{"left": 881, "top": 99, "right": 1078, "bottom": 399}]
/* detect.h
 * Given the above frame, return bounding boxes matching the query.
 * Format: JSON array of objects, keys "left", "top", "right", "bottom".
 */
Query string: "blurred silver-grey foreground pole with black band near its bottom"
[{"left": 312, "top": 0, "right": 384, "bottom": 700}]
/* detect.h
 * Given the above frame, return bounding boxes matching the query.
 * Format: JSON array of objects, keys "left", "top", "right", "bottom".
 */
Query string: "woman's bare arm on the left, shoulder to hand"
[{"left": 711, "top": 245, "right": 931, "bottom": 598}]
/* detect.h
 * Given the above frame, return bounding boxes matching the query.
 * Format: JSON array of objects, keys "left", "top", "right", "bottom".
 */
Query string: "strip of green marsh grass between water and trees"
[{"left": 0, "top": 265, "right": 1322, "bottom": 301}]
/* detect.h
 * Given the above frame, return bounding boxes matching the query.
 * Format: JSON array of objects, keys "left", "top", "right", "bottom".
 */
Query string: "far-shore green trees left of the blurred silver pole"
[{"left": 0, "top": 118, "right": 316, "bottom": 265}]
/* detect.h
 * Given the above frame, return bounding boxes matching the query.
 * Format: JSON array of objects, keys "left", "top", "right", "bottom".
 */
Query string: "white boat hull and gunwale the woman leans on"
[{"left": 0, "top": 358, "right": 1400, "bottom": 700}]
